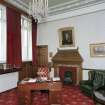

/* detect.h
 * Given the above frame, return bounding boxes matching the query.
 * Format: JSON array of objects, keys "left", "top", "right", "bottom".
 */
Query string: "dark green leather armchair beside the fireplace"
[{"left": 80, "top": 70, "right": 105, "bottom": 97}]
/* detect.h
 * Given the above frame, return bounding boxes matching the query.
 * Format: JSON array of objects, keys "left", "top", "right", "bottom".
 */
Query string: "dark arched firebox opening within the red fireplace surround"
[{"left": 63, "top": 70, "right": 73, "bottom": 85}]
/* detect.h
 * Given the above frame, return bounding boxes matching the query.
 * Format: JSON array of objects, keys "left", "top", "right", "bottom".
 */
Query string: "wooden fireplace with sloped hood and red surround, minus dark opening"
[{"left": 52, "top": 49, "right": 83, "bottom": 85}]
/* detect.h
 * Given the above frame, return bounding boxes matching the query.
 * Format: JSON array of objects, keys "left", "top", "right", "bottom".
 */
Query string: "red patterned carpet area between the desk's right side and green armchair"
[{"left": 62, "top": 87, "right": 95, "bottom": 105}]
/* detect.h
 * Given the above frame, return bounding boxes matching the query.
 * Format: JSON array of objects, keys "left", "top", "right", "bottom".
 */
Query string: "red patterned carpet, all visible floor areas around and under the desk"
[{"left": 0, "top": 86, "right": 95, "bottom": 105}]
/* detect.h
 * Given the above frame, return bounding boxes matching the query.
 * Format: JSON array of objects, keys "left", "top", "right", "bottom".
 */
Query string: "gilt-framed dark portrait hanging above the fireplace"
[{"left": 59, "top": 27, "right": 75, "bottom": 47}]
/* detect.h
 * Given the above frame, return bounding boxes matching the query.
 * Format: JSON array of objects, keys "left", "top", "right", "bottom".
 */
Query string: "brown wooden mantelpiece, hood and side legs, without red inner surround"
[{"left": 52, "top": 49, "right": 83, "bottom": 85}]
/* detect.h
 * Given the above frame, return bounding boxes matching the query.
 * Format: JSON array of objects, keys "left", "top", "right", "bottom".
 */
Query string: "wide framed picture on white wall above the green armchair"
[{"left": 90, "top": 43, "right": 105, "bottom": 57}]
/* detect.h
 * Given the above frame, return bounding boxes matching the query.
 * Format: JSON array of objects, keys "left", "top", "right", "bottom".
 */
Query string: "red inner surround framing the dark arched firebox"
[{"left": 59, "top": 66, "right": 78, "bottom": 84}]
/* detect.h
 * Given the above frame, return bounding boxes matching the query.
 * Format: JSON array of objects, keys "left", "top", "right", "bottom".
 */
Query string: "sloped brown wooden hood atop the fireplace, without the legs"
[{"left": 52, "top": 49, "right": 83, "bottom": 65}]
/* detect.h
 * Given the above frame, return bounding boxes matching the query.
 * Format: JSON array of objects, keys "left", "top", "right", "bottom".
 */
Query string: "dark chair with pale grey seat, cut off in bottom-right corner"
[{"left": 94, "top": 85, "right": 105, "bottom": 105}]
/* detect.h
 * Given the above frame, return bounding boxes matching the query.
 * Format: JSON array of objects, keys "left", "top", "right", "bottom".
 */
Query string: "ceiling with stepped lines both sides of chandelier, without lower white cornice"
[{"left": 5, "top": 0, "right": 105, "bottom": 16}]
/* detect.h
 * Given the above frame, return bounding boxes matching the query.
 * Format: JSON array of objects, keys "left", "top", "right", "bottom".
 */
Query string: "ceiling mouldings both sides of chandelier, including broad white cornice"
[{"left": 5, "top": 0, "right": 105, "bottom": 23}]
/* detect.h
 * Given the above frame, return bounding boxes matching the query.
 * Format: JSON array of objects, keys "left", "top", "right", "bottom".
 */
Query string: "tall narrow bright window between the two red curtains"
[{"left": 21, "top": 16, "right": 32, "bottom": 61}]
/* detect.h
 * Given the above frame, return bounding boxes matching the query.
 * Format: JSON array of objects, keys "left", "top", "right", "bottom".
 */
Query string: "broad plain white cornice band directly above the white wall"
[{"left": 45, "top": 3, "right": 105, "bottom": 23}]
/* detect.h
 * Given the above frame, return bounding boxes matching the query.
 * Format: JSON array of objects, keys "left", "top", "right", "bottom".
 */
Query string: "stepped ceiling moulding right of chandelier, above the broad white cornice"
[{"left": 49, "top": 0, "right": 105, "bottom": 16}]
